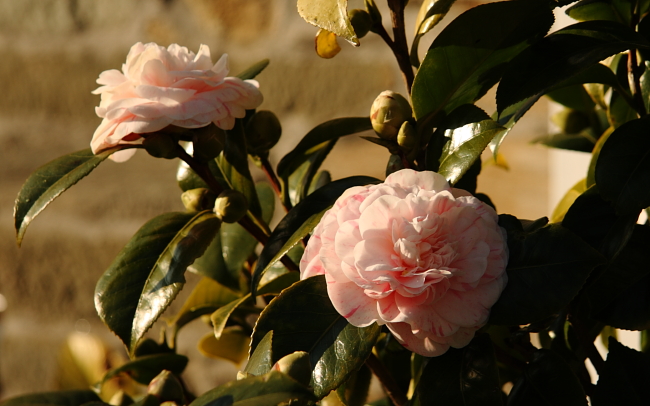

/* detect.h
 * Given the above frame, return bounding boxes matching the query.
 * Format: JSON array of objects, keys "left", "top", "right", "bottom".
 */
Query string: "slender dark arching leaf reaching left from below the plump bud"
[{"left": 277, "top": 117, "right": 372, "bottom": 179}]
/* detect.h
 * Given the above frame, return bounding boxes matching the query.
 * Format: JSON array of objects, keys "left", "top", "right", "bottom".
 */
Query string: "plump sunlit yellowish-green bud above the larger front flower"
[{"left": 370, "top": 90, "right": 413, "bottom": 140}]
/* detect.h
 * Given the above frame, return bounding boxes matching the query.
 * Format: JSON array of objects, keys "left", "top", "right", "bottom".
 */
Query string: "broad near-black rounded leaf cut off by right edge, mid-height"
[{"left": 595, "top": 117, "right": 650, "bottom": 213}]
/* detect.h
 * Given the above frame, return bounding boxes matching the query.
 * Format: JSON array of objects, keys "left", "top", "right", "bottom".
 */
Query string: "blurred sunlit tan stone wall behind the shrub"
[{"left": 0, "top": 0, "right": 548, "bottom": 398}]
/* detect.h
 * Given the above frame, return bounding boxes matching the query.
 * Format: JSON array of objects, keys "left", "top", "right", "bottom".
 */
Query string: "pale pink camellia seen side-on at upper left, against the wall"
[{"left": 90, "top": 42, "right": 262, "bottom": 161}]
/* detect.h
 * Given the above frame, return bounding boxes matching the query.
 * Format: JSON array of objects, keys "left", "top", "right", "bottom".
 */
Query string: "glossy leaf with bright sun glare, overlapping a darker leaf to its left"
[{"left": 130, "top": 211, "right": 221, "bottom": 351}]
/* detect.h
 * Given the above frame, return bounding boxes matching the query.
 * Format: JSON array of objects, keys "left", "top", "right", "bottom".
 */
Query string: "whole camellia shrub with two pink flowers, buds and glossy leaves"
[{"left": 3, "top": 0, "right": 650, "bottom": 406}]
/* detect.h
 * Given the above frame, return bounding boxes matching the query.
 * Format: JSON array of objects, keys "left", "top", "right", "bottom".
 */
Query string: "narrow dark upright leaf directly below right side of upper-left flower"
[{"left": 217, "top": 120, "right": 262, "bottom": 216}]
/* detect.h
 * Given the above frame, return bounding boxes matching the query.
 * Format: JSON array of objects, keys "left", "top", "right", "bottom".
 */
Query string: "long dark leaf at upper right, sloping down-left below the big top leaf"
[{"left": 497, "top": 21, "right": 650, "bottom": 115}]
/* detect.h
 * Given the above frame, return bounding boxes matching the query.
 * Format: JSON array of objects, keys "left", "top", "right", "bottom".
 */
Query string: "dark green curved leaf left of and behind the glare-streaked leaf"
[{"left": 95, "top": 213, "right": 195, "bottom": 347}]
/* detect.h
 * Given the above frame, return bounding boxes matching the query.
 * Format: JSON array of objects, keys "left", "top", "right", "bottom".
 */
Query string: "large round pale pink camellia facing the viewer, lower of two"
[{"left": 300, "top": 169, "right": 508, "bottom": 357}]
